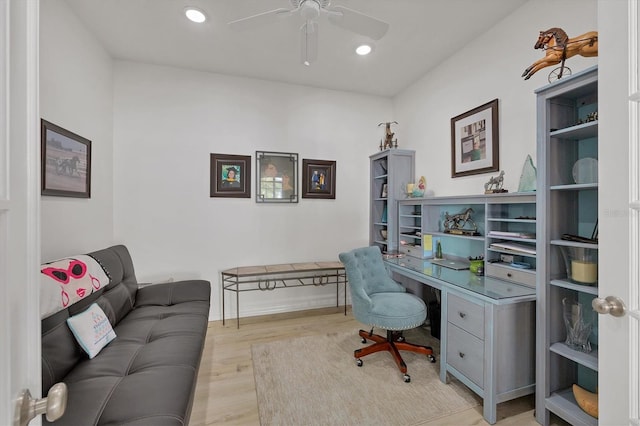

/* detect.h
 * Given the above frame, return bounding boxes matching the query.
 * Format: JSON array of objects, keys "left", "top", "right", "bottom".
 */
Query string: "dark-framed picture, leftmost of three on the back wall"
[{"left": 209, "top": 154, "right": 251, "bottom": 198}]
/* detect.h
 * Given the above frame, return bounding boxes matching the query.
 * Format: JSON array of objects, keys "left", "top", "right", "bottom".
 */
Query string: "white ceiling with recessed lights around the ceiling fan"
[{"left": 66, "top": 0, "right": 527, "bottom": 96}]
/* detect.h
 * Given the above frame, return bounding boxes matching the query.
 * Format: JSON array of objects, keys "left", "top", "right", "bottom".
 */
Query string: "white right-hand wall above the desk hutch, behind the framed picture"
[{"left": 394, "top": 0, "right": 598, "bottom": 195}]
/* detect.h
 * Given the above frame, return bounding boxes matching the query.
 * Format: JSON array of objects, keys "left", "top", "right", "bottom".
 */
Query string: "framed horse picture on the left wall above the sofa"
[{"left": 40, "top": 120, "right": 91, "bottom": 198}]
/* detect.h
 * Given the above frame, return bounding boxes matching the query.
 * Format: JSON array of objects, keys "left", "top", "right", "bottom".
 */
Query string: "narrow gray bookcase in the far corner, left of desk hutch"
[{"left": 369, "top": 149, "right": 415, "bottom": 252}]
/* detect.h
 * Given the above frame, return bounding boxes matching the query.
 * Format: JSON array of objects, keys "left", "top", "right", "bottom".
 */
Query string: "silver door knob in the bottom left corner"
[{"left": 13, "top": 382, "right": 67, "bottom": 426}]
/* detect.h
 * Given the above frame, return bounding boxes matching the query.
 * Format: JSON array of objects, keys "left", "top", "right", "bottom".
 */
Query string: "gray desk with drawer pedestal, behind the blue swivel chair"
[{"left": 385, "top": 257, "right": 536, "bottom": 424}]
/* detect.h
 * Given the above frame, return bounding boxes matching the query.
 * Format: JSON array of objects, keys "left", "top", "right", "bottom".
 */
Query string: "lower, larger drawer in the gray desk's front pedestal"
[{"left": 447, "top": 323, "right": 484, "bottom": 389}]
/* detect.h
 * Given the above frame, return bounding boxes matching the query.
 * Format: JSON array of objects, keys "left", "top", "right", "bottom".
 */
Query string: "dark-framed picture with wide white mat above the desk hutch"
[{"left": 451, "top": 99, "right": 500, "bottom": 178}]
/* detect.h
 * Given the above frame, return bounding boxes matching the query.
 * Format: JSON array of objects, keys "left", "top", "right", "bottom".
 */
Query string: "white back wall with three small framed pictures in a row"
[{"left": 114, "top": 62, "right": 392, "bottom": 318}]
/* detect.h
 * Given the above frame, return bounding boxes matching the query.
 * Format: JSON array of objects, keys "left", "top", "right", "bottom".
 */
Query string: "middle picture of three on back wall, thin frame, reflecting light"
[{"left": 256, "top": 151, "right": 298, "bottom": 203}]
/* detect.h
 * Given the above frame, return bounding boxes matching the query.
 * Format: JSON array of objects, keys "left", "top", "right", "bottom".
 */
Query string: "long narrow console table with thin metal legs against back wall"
[{"left": 221, "top": 262, "right": 347, "bottom": 328}]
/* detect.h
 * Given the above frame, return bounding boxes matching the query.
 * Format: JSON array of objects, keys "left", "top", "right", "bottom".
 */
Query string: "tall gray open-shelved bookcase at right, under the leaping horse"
[{"left": 536, "top": 67, "right": 598, "bottom": 425}]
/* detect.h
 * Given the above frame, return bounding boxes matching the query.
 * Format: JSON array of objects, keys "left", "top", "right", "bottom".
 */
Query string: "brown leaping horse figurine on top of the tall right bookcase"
[{"left": 522, "top": 28, "right": 598, "bottom": 80}]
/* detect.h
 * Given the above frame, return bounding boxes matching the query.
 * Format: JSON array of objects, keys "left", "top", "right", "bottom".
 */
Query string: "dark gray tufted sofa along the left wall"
[{"left": 42, "top": 245, "right": 210, "bottom": 426}]
